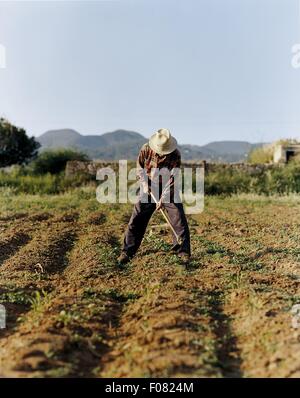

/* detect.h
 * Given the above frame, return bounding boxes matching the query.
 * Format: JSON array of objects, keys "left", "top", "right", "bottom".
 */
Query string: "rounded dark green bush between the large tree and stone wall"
[{"left": 30, "top": 149, "right": 88, "bottom": 174}]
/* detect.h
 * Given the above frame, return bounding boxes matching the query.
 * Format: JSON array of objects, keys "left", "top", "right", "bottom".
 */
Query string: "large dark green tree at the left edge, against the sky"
[{"left": 0, "top": 118, "right": 40, "bottom": 167}]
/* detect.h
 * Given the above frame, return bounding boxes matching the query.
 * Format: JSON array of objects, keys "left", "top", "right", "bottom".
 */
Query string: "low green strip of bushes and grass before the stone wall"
[{"left": 0, "top": 155, "right": 300, "bottom": 196}]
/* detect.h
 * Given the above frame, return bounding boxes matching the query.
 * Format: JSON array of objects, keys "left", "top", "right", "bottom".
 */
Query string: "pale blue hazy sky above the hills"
[{"left": 0, "top": 0, "right": 300, "bottom": 144}]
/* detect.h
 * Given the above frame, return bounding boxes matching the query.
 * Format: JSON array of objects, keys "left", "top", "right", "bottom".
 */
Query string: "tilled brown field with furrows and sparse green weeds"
[{"left": 0, "top": 193, "right": 300, "bottom": 377}]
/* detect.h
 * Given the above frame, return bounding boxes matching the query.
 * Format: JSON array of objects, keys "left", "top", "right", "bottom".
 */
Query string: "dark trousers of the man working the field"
[{"left": 122, "top": 201, "right": 191, "bottom": 256}]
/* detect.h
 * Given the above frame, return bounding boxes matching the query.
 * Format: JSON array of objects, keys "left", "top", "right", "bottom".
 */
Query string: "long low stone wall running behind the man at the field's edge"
[{"left": 66, "top": 160, "right": 282, "bottom": 177}]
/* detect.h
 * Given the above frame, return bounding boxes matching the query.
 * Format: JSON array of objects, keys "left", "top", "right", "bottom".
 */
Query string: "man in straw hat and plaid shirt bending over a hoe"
[{"left": 118, "top": 129, "right": 191, "bottom": 264}]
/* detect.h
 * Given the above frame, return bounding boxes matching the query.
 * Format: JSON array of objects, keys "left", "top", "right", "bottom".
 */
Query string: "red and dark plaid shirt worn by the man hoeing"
[{"left": 137, "top": 144, "right": 181, "bottom": 198}]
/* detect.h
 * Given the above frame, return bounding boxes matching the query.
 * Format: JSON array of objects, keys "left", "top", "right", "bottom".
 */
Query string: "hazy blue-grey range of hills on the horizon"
[{"left": 37, "top": 129, "right": 262, "bottom": 163}]
